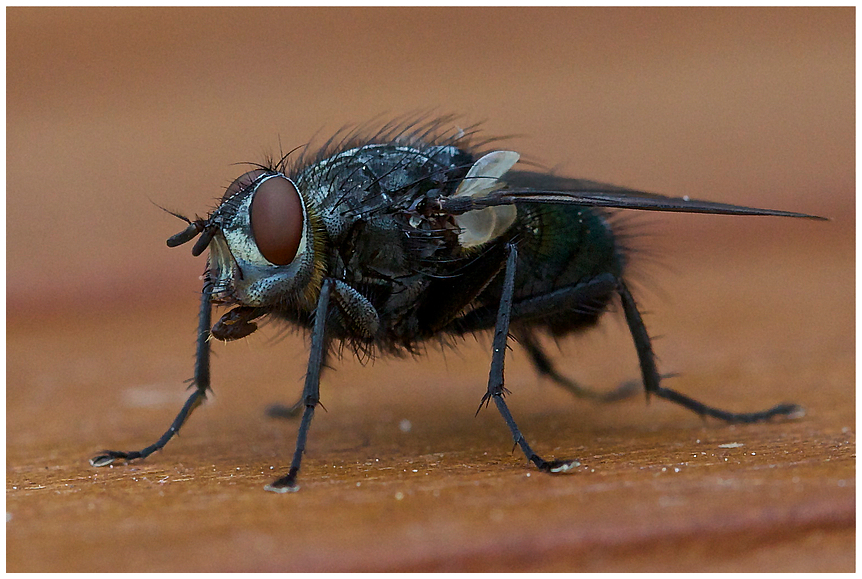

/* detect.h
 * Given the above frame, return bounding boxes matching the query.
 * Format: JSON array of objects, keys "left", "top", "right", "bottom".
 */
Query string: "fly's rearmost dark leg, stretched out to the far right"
[{"left": 617, "top": 280, "right": 805, "bottom": 422}]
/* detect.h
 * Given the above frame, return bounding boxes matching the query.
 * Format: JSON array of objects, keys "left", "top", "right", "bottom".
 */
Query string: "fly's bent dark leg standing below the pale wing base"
[{"left": 476, "top": 244, "right": 580, "bottom": 473}]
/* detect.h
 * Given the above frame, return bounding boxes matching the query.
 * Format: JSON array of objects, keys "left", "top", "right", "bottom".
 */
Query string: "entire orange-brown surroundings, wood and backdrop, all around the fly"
[{"left": 6, "top": 8, "right": 855, "bottom": 570}]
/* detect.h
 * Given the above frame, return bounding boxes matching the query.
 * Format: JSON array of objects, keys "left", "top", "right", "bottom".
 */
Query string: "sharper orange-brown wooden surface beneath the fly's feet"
[{"left": 7, "top": 222, "right": 855, "bottom": 571}]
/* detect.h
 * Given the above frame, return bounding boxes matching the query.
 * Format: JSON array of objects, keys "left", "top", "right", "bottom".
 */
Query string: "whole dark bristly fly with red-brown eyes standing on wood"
[{"left": 90, "top": 119, "right": 822, "bottom": 492}]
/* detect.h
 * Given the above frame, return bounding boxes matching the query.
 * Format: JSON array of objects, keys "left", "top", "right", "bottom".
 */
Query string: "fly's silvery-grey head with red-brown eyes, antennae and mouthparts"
[{"left": 168, "top": 169, "right": 322, "bottom": 340}]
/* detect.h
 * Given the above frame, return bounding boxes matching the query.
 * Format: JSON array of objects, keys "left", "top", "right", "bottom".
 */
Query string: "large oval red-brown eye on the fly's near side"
[{"left": 250, "top": 171, "right": 303, "bottom": 265}]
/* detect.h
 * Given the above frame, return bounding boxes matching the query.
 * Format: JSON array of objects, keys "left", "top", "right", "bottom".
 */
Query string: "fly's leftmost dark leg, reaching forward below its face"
[{"left": 90, "top": 282, "right": 212, "bottom": 466}]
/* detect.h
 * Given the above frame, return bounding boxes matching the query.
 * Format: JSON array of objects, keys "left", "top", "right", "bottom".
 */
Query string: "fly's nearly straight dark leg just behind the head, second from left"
[{"left": 264, "top": 279, "right": 332, "bottom": 493}]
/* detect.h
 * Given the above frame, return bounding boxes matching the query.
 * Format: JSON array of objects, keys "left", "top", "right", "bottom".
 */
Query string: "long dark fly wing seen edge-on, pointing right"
[{"left": 456, "top": 171, "right": 826, "bottom": 220}]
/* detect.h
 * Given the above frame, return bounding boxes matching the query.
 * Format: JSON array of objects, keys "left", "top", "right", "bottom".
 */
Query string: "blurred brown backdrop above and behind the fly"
[{"left": 6, "top": 8, "right": 855, "bottom": 318}]
